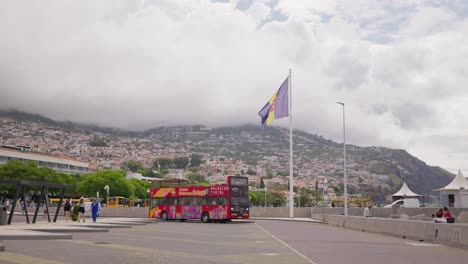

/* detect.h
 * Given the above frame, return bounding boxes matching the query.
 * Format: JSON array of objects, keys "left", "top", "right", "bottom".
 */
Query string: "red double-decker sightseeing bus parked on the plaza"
[{"left": 149, "top": 176, "right": 250, "bottom": 223}]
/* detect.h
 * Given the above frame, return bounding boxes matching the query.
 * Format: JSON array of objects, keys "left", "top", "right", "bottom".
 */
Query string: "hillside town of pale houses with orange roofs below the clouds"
[{"left": 0, "top": 114, "right": 414, "bottom": 204}]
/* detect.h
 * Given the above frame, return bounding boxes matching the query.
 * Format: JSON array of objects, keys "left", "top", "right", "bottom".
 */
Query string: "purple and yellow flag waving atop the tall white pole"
[{"left": 258, "top": 76, "right": 289, "bottom": 127}]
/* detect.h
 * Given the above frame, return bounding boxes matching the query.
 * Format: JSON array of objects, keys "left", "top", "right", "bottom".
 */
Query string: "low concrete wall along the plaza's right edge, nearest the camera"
[{"left": 312, "top": 214, "right": 468, "bottom": 248}]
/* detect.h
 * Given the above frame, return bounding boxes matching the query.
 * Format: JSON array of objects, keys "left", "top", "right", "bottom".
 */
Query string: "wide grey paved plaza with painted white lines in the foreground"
[{"left": 0, "top": 218, "right": 468, "bottom": 264}]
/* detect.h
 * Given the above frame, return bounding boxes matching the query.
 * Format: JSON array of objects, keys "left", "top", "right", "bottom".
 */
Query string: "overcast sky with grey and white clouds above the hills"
[{"left": 0, "top": 0, "right": 468, "bottom": 176}]
